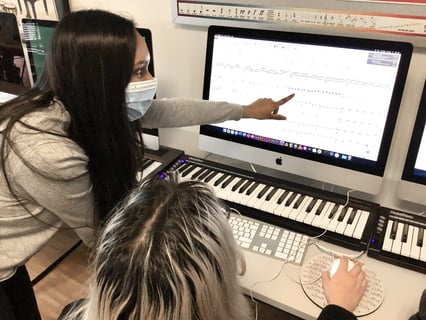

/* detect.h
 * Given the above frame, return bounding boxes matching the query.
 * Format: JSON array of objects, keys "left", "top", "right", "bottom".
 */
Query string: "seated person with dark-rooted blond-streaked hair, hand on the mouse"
[{"left": 60, "top": 177, "right": 366, "bottom": 320}]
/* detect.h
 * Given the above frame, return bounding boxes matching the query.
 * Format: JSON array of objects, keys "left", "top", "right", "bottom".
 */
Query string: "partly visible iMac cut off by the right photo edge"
[{"left": 398, "top": 80, "right": 426, "bottom": 205}]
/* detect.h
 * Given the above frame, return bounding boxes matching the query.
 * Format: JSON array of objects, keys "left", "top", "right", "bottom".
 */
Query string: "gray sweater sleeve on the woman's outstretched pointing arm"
[{"left": 142, "top": 98, "right": 243, "bottom": 128}]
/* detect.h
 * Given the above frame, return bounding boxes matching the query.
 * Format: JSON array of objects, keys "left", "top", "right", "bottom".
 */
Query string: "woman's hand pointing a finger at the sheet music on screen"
[{"left": 243, "top": 93, "right": 294, "bottom": 120}]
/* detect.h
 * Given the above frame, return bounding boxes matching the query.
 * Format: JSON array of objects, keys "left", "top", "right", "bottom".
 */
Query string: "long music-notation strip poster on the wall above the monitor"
[{"left": 175, "top": 0, "right": 426, "bottom": 46}]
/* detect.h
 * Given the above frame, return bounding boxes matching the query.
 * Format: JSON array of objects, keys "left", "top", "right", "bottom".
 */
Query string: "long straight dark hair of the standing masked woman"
[{"left": 0, "top": 10, "right": 143, "bottom": 223}]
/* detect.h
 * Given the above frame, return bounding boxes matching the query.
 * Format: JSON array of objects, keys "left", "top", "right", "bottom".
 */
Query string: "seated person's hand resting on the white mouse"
[{"left": 322, "top": 257, "right": 367, "bottom": 312}]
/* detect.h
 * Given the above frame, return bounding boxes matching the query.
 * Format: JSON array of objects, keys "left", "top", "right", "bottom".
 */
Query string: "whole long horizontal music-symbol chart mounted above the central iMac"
[{"left": 172, "top": 0, "right": 426, "bottom": 47}]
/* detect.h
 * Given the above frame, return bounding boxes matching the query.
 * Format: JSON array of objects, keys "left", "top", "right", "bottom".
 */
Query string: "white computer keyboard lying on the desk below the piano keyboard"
[{"left": 229, "top": 213, "right": 309, "bottom": 265}]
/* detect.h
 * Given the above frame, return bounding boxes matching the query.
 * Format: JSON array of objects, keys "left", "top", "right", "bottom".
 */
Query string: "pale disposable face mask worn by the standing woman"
[{"left": 126, "top": 78, "right": 157, "bottom": 121}]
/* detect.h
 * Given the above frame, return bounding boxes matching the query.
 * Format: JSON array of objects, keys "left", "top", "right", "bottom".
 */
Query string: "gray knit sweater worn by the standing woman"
[{"left": 0, "top": 99, "right": 243, "bottom": 281}]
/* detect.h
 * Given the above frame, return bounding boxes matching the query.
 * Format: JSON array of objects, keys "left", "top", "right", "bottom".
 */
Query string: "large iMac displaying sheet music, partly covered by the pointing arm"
[{"left": 200, "top": 26, "right": 413, "bottom": 194}]
